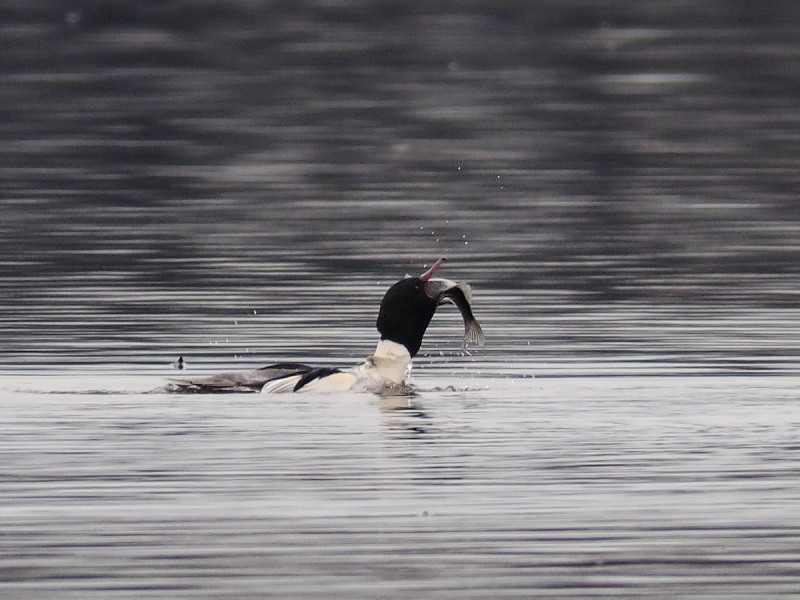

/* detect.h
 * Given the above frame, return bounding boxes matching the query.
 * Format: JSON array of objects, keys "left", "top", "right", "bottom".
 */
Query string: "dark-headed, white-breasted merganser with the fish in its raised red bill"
[{"left": 167, "top": 258, "right": 484, "bottom": 393}]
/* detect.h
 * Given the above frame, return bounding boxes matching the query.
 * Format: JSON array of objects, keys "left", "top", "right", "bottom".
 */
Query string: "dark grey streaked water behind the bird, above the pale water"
[{"left": 0, "top": 0, "right": 800, "bottom": 370}]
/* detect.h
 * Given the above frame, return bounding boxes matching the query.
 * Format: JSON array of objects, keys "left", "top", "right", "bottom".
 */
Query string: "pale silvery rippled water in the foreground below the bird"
[{"left": 0, "top": 376, "right": 800, "bottom": 598}]
